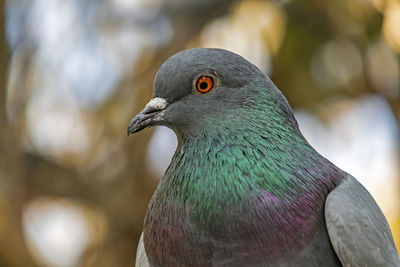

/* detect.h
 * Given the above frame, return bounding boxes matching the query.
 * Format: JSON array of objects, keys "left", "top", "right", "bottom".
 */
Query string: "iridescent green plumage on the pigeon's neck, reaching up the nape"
[{"left": 158, "top": 80, "right": 336, "bottom": 224}]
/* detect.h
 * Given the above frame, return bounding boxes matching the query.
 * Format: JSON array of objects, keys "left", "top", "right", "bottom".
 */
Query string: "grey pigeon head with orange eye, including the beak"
[{"left": 128, "top": 48, "right": 291, "bottom": 136}]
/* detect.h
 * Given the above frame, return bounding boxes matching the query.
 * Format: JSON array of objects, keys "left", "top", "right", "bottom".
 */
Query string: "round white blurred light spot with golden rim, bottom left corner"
[{"left": 22, "top": 197, "right": 106, "bottom": 267}]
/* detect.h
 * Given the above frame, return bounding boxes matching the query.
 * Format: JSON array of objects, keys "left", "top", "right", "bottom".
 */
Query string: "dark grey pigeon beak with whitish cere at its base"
[{"left": 128, "top": 97, "right": 168, "bottom": 136}]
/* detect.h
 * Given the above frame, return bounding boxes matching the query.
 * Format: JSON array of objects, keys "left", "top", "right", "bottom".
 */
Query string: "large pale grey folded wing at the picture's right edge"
[{"left": 325, "top": 175, "right": 400, "bottom": 266}]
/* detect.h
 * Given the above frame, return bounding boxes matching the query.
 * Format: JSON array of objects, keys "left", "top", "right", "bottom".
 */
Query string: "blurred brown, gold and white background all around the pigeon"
[{"left": 0, "top": 0, "right": 400, "bottom": 267}]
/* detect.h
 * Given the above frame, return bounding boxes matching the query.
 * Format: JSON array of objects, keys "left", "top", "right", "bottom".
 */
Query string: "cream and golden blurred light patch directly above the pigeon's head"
[{"left": 192, "top": 0, "right": 286, "bottom": 73}]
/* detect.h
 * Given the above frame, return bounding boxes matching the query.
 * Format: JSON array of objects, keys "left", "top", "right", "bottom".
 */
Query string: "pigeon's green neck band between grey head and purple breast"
[{"left": 163, "top": 126, "right": 336, "bottom": 201}]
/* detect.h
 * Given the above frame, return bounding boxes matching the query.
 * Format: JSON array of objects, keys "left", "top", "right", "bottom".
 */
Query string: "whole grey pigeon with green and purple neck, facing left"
[{"left": 128, "top": 48, "right": 400, "bottom": 266}]
